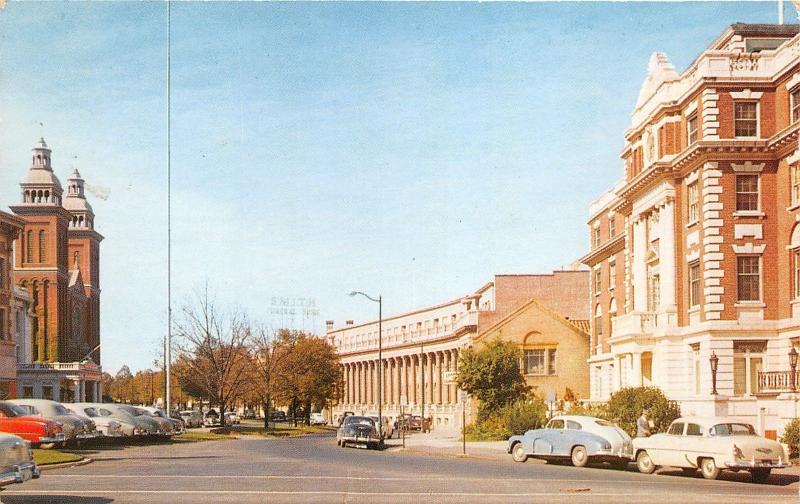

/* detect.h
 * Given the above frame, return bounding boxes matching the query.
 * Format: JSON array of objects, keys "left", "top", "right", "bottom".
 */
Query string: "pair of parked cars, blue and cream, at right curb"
[{"left": 508, "top": 415, "right": 791, "bottom": 483}]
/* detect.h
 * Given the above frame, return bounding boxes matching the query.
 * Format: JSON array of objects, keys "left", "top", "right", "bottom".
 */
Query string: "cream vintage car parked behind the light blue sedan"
[{"left": 633, "top": 417, "right": 791, "bottom": 483}]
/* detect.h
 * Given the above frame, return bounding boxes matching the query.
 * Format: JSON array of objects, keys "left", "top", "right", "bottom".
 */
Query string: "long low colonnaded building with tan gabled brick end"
[{"left": 327, "top": 270, "right": 589, "bottom": 429}]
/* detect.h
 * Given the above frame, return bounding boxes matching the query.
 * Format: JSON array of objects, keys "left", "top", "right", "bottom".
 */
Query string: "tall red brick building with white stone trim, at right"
[{"left": 583, "top": 24, "right": 800, "bottom": 437}]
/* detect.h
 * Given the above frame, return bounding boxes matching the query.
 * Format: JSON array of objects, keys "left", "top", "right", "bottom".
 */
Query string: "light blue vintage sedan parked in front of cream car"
[{"left": 507, "top": 415, "right": 633, "bottom": 469}]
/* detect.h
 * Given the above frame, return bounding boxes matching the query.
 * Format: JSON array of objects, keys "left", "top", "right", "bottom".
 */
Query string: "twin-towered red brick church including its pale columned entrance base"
[{"left": 11, "top": 139, "right": 103, "bottom": 401}]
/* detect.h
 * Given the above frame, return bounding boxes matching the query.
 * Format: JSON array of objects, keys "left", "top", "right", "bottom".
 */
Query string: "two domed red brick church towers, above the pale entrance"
[{"left": 11, "top": 139, "right": 103, "bottom": 362}]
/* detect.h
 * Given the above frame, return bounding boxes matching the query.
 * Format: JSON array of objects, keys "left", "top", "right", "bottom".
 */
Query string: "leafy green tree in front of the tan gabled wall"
[{"left": 456, "top": 339, "right": 531, "bottom": 420}]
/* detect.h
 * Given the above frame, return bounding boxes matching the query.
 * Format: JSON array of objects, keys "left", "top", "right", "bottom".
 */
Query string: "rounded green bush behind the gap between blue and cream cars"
[{"left": 607, "top": 387, "right": 681, "bottom": 436}]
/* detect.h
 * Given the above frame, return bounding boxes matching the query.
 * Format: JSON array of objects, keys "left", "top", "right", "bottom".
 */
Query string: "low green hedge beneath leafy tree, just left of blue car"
[{"left": 466, "top": 397, "right": 547, "bottom": 441}]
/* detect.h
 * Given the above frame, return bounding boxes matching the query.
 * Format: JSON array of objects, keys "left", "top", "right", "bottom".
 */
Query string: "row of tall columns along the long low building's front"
[{"left": 341, "top": 348, "right": 458, "bottom": 406}]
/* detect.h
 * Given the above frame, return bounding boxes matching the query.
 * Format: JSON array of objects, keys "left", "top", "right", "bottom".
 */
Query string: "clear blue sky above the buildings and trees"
[{"left": 0, "top": 2, "right": 794, "bottom": 372}]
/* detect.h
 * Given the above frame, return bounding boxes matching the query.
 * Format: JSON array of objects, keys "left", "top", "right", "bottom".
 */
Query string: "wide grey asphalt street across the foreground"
[{"left": 0, "top": 434, "right": 800, "bottom": 504}]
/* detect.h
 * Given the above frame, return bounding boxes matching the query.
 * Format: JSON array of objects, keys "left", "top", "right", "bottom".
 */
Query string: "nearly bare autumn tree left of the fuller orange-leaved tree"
[{"left": 175, "top": 287, "right": 251, "bottom": 427}]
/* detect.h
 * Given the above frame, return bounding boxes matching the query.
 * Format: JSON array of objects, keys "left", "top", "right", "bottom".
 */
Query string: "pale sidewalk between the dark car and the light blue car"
[{"left": 386, "top": 432, "right": 510, "bottom": 460}]
